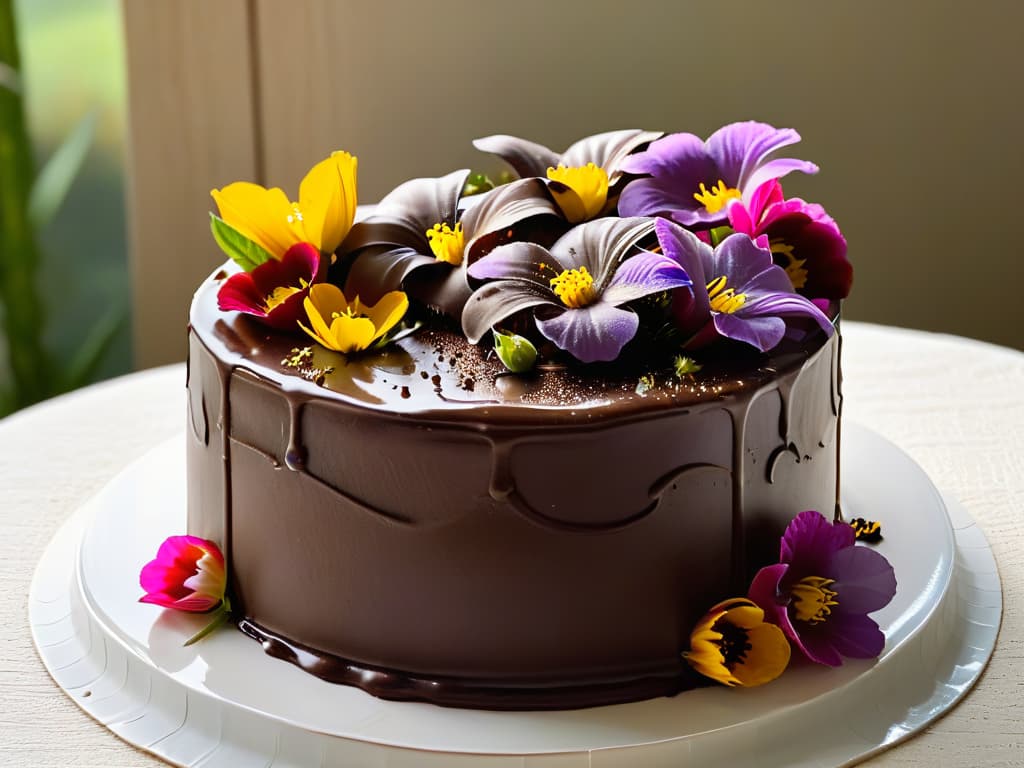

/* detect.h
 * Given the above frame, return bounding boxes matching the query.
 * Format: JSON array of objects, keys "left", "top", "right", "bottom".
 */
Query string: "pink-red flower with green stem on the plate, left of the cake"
[{"left": 138, "top": 536, "right": 231, "bottom": 645}]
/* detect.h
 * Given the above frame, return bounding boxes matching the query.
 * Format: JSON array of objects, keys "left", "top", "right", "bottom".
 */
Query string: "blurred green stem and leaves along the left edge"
[{"left": 0, "top": 0, "right": 126, "bottom": 415}]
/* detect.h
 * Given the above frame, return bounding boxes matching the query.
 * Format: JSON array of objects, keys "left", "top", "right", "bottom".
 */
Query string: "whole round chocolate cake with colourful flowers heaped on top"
[{"left": 178, "top": 123, "right": 864, "bottom": 709}]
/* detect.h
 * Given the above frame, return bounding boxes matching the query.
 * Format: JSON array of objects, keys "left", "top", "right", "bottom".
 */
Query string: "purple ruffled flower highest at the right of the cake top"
[{"left": 618, "top": 122, "right": 818, "bottom": 228}]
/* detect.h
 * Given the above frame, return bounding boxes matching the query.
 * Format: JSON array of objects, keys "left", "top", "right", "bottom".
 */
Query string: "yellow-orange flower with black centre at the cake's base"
[{"left": 683, "top": 598, "right": 791, "bottom": 687}]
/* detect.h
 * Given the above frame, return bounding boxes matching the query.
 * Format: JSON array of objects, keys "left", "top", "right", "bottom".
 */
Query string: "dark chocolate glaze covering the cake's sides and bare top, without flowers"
[{"left": 188, "top": 268, "right": 841, "bottom": 709}]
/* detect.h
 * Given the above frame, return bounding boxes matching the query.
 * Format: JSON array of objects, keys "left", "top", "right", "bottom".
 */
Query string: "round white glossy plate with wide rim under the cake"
[{"left": 30, "top": 424, "right": 1001, "bottom": 768}]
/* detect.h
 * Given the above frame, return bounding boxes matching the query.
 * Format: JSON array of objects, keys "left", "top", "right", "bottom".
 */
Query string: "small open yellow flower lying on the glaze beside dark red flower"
[{"left": 299, "top": 283, "right": 409, "bottom": 354}]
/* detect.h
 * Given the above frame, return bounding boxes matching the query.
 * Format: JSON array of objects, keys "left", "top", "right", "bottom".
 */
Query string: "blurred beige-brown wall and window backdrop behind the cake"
[{"left": 0, "top": 0, "right": 1024, "bottom": 421}]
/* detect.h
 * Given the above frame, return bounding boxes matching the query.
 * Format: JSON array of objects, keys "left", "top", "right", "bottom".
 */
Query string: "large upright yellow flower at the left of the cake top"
[{"left": 210, "top": 152, "right": 357, "bottom": 259}]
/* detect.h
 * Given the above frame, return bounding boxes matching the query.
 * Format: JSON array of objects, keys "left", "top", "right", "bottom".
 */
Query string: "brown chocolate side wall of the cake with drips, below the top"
[{"left": 188, "top": 327, "right": 838, "bottom": 700}]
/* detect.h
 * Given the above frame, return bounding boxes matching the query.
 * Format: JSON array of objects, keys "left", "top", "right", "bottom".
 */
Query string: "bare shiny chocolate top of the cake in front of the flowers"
[{"left": 190, "top": 270, "right": 825, "bottom": 424}]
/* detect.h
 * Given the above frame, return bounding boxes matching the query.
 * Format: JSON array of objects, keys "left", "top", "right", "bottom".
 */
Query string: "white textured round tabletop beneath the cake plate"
[{"left": 0, "top": 323, "right": 1024, "bottom": 768}]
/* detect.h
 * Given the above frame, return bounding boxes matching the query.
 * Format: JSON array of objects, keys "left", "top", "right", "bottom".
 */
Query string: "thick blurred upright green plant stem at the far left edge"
[{"left": 0, "top": 0, "right": 53, "bottom": 413}]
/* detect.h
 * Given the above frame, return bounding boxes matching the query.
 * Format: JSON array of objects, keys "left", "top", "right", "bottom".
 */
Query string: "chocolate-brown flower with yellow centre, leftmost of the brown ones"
[{"left": 345, "top": 170, "right": 556, "bottom": 318}]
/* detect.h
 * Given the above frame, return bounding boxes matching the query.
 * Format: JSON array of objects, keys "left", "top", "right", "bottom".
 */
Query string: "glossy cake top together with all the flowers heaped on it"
[{"left": 193, "top": 122, "right": 852, "bottom": 418}]
